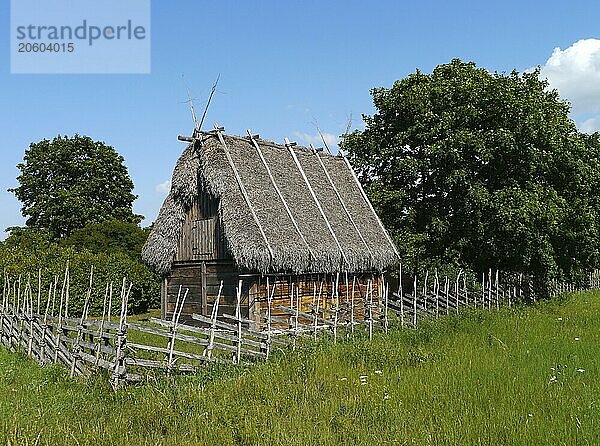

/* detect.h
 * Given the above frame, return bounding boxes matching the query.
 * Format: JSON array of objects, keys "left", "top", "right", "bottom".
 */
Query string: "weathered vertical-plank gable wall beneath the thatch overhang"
[{"left": 175, "top": 187, "right": 231, "bottom": 262}]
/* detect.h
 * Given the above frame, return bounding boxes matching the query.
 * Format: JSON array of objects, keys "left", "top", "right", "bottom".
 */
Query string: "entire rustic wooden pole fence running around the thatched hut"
[{"left": 0, "top": 267, "right": 600, "bottom": 387}]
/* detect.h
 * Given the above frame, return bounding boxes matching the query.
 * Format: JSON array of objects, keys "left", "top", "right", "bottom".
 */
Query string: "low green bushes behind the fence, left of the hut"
[{"left": 0, "top": 223, "right": 160, "bottom": 315}]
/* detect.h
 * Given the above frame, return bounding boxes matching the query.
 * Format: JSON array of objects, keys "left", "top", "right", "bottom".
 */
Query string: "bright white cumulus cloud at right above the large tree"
[{"left": 540, "top": 39, "right": 600, "bottom": 114}]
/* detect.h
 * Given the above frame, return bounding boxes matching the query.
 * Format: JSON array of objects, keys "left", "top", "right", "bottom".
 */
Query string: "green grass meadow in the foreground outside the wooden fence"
[{"left": 0, "top": 292, "right": 600, "bottom": 445}]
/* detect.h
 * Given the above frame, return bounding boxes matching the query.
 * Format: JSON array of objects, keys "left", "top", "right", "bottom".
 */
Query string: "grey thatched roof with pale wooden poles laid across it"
[{"left": 142, "top": 132, "right": 397, "bottom": 274}]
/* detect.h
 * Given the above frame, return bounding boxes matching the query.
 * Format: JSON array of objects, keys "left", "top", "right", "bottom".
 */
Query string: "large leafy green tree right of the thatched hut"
[{"left": 342, "top": 60, "right": 600, "bottom": 283}]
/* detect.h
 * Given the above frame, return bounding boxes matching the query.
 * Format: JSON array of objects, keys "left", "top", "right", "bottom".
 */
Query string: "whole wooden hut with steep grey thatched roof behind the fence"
[{"left": 142, "top": 128, "right": 398, "bottom": 320}]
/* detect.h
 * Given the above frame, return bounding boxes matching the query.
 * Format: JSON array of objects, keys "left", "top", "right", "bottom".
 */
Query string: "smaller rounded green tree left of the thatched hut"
[{"left": 10, "top": 135, "right": 141, "bottom": 238}]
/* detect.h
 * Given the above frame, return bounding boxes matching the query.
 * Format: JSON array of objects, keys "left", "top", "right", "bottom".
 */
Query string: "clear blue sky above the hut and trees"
[{"left": 0, "top": 0, "right": 600, "bottom": 238}]
